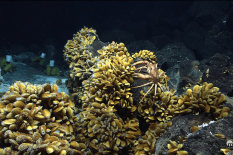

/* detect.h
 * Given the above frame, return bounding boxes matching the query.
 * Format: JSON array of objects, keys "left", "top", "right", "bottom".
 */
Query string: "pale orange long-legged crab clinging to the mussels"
[{"left": 131, "top": 60, "right": 168, "bottom": 103}]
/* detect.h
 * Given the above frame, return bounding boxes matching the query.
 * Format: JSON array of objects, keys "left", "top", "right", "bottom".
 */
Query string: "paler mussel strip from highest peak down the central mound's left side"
[{"left": 63, "top": 27, "right": 98, "bottom": 107}]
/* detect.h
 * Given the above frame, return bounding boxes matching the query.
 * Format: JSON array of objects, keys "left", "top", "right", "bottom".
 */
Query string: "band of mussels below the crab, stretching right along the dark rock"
[{"left": 137, "top": 82, "right": 230, "bottom": 125}]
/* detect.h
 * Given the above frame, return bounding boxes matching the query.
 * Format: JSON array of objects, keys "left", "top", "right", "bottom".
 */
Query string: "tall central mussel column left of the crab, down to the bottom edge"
[{"left": 79, "top": 42, "right": 141, "bottom": 154}]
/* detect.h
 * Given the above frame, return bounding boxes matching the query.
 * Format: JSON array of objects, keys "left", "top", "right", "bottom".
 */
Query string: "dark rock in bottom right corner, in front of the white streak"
[{"left": 182, "top": 116, "right": 233, "bottom": 155}]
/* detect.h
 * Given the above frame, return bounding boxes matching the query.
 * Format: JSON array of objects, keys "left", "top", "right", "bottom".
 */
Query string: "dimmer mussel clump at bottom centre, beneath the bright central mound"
[{"left": 76, "top": 103, "right": 141, "bottom": 154}]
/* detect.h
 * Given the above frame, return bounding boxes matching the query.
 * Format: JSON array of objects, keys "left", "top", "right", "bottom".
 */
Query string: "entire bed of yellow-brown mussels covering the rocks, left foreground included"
[{"left": 0, "top": 27, "right": 229, "bottom": 155}]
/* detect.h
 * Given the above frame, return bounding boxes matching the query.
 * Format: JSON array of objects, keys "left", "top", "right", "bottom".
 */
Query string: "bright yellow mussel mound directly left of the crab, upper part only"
[{"left": 82, "top": 42, "right": 136, "bottom": 111}]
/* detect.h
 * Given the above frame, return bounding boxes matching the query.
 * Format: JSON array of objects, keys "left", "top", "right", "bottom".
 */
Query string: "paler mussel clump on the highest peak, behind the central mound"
[{"left": 64, "top": 27, "right": 97, "bottom": 80}]
